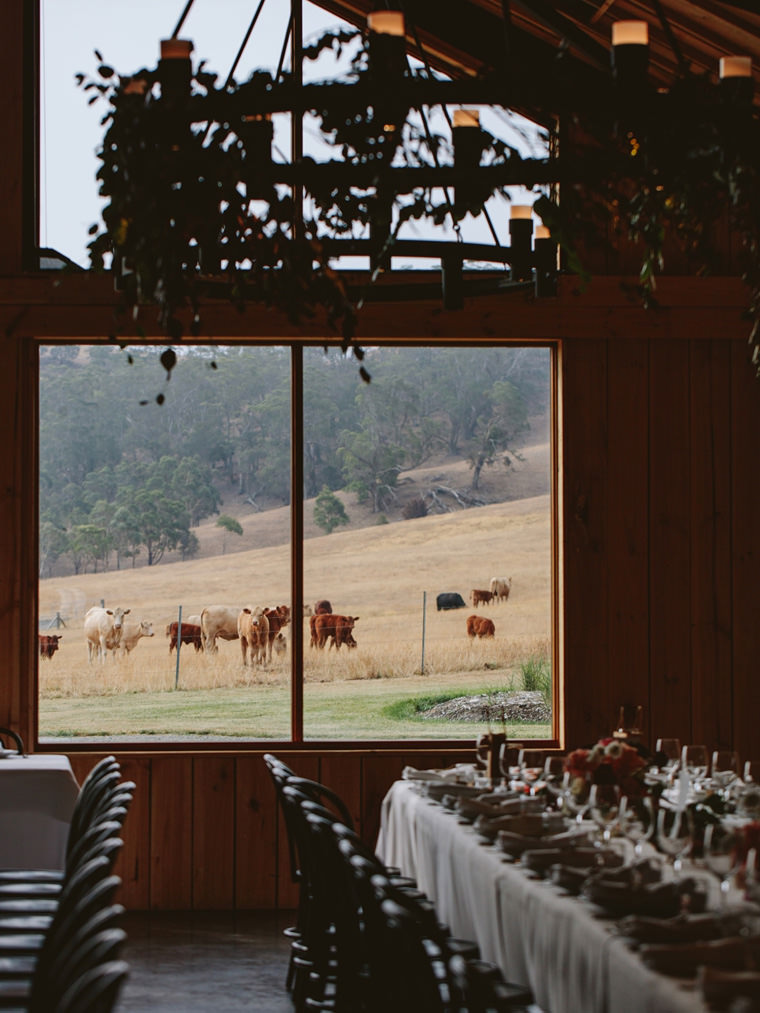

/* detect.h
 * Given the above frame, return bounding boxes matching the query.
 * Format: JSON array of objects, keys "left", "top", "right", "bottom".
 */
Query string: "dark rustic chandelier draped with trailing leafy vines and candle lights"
[{"left": 79, "top": 0, "right": 760, "bottom": 380}]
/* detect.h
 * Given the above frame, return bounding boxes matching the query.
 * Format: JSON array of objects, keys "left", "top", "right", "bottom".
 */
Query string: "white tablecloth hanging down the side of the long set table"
[{"left": 377, "top": 781, "right": 705, "bottom": 1013}]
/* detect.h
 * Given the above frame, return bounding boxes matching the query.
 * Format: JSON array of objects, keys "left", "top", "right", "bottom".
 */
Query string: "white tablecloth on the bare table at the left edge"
[{"left": 0, "top": 754, "right": 79, "bottom": 869}]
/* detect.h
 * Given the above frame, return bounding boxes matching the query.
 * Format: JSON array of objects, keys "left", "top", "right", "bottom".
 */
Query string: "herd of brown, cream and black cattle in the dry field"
[{"left": 37, "top": 577, "right": 512, "bottom": 665}]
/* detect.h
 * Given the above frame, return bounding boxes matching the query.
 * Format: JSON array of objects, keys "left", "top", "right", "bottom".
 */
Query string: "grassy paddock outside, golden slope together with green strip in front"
[{"left": 40, "top": 497, "right": 551, "bottom": 738}]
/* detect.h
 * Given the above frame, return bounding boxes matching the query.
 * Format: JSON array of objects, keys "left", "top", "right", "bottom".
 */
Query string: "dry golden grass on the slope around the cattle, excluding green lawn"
[{"left": 40, "top": 482, "right": 550, "bottom": 733}]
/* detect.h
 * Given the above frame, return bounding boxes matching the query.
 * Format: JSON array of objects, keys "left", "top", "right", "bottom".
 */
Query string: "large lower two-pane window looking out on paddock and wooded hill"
[{"left": 40, "top": 345, "right": 553, "bottom": 741}]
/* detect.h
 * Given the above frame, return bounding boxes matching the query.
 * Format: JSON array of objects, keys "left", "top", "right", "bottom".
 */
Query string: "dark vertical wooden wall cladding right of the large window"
[{"left": 560, "top": 332, "right": 760, "bottom": 759}]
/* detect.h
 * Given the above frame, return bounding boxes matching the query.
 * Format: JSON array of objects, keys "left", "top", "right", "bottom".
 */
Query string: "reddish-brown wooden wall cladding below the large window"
[{"left": 65, "top": 749, "right": 472, "bottom": 911}]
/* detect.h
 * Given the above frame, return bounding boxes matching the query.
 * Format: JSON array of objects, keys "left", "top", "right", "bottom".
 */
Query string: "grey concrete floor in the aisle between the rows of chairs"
[{"left": 116, "top": 912, "right": 293, "bottom": 1013}]
